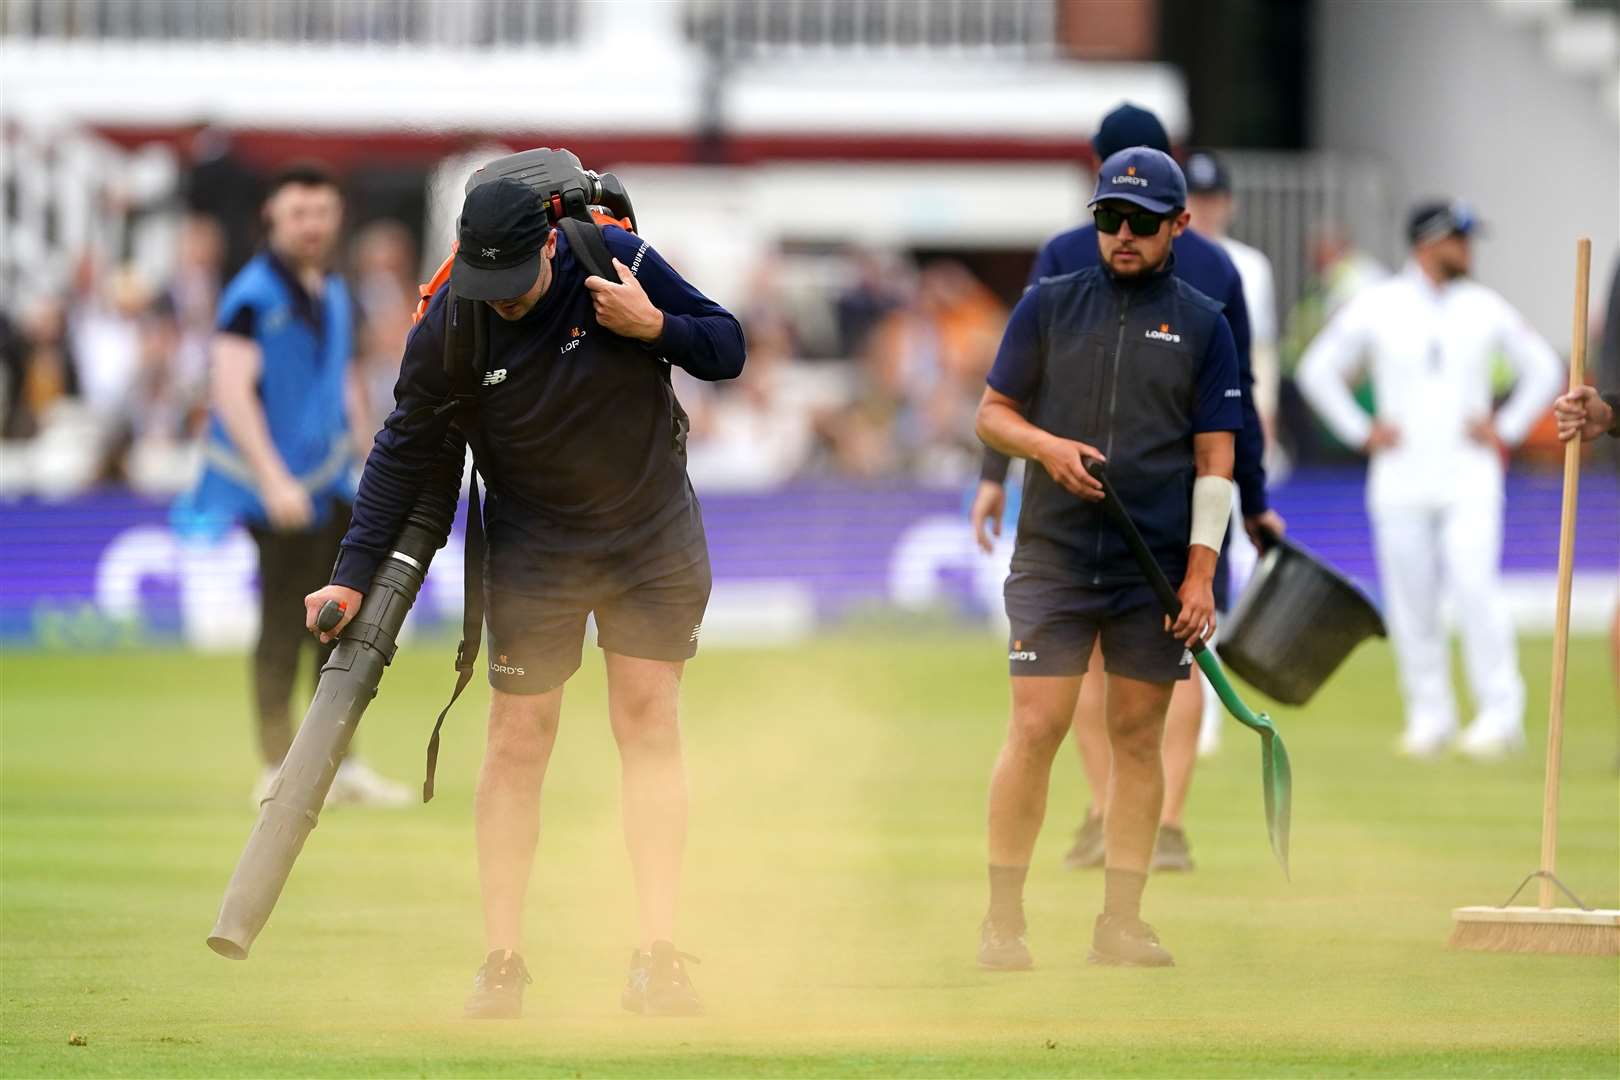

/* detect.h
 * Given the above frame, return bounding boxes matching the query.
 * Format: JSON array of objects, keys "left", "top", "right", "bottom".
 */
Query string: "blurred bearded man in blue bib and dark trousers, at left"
[{"left": 175, "top": 165, "right": 410, "bottom": 805}]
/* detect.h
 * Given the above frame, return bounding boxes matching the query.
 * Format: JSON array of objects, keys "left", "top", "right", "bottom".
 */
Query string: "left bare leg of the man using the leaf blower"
[{"left": 473, "top": 687, "right": 562, "bottom": 952}]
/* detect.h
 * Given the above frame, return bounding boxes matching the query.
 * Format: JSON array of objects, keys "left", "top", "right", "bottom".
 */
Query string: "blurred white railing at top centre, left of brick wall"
[{"left": 685, "top": 0, "right": 1058, "bottom": 58}]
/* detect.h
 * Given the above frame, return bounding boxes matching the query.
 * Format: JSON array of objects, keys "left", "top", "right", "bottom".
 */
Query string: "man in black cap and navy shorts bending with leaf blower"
[{"left": 306, "top": 176, "right": 744, "bottom": 1018}]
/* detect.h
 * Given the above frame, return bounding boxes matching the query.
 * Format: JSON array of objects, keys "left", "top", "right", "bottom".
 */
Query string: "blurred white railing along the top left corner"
[{"left": 0, "top": 0, "right": 583, "bottom": 47}]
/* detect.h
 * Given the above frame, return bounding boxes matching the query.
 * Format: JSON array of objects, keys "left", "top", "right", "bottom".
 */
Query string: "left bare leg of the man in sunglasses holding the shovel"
[{"left": 990, "top": 675, "right": 1100, "bottom": 866}]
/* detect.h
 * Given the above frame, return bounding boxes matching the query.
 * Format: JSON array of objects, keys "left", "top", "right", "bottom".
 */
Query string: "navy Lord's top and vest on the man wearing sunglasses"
[{"left": 988, "top": 266, "right": 1243, "bottom": 588}]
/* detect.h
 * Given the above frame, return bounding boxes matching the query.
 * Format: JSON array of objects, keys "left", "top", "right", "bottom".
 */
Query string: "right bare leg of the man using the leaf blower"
[{"left": 604, "top": 653, "right": 687, "bottom": 952}]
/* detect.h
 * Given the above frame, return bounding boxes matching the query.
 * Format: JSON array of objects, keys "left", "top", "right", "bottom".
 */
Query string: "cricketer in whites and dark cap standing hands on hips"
[{"left": 1298, "top": 219, "right": 1562, "bottom": 758}]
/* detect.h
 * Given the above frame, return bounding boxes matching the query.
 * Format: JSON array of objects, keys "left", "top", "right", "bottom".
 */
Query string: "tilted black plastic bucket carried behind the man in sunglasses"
[{"left": 1215, "top": 538, "right": 1385, "bottom": 704}]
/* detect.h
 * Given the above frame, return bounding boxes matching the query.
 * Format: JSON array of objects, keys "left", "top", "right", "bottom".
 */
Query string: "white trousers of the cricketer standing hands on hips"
[{"left": 1371, "top": 499, "right": 1524, "bottom": 742}]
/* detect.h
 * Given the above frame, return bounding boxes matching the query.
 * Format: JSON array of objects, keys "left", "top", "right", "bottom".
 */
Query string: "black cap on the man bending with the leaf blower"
[{"left": 450, "top": 176, "right": 551, "bottom": 300}]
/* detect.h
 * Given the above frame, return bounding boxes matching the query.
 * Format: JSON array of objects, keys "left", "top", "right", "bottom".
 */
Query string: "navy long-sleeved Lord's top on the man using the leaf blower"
[{"left": 332, "top": 225, "right": 744, "bottom": 591}]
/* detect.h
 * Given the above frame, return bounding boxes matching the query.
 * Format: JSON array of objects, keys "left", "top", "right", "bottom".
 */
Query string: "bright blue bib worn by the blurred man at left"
[{"left": 175, "top": 251, "right": 353, "bottom": 534}]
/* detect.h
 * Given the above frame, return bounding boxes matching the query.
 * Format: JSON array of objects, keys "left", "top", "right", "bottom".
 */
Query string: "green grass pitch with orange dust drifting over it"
[{"left": 0, "top": 630, "right": 1620, "bottom": 1077}]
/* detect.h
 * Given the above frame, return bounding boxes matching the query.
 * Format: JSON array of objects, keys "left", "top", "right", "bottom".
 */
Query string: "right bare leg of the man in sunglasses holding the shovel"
[{"left": 1103, "top": 675, "right": 1171, "bottom": 874}]
